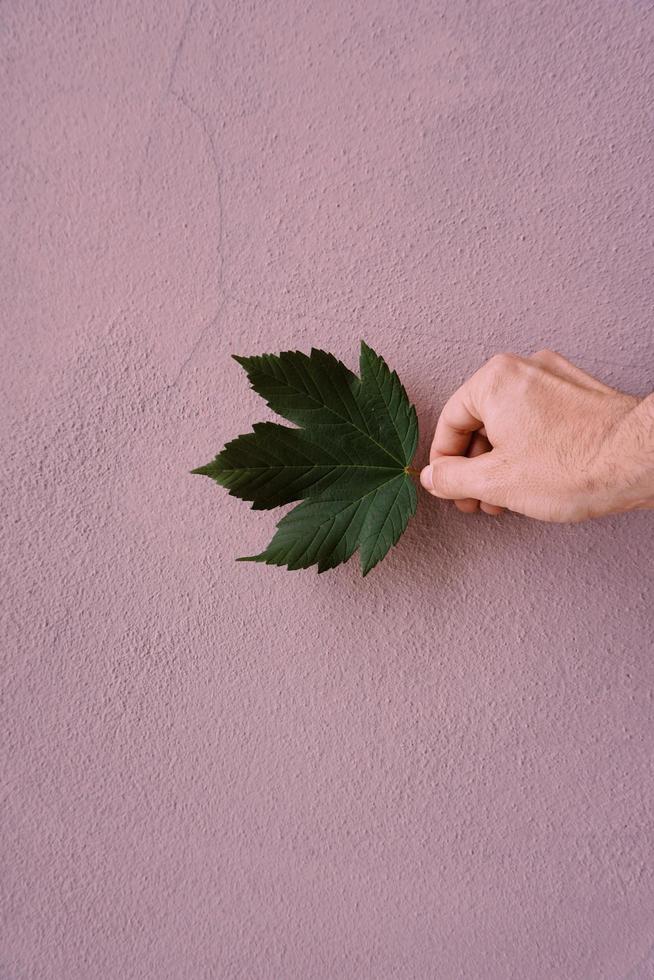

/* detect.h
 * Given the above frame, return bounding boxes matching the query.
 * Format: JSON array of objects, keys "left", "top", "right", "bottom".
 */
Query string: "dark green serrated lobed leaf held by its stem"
[{"left": 193, "top": 341, "right": 418, "bottom": 575}]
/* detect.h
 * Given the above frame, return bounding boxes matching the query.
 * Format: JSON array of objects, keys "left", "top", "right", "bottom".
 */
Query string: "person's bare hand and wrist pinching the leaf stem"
[{"left": 420, "top": 351, "right": 654, "bottom": 521}]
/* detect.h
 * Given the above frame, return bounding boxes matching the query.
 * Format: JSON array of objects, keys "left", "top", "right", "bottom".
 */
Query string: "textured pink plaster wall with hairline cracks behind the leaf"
[{"left": 0, "top": 0, "right": 654, "bottom": 980}]
